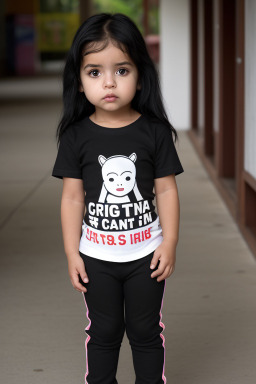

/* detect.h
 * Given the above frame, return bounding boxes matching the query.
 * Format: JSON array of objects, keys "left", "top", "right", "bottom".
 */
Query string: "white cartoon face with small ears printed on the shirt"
[{"left": 98, "top": 153, "right": 137, "bottom": 197}]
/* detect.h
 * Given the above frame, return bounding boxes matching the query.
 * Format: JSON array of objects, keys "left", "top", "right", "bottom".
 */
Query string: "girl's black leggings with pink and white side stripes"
[{"left": 80, "top": 252, "right": 166, "bottom": 384}]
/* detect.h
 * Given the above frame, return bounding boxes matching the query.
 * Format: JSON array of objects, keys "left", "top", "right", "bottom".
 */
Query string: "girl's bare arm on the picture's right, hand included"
[{"left": 150, "top": 174, "right": 180, "bottom": 281}]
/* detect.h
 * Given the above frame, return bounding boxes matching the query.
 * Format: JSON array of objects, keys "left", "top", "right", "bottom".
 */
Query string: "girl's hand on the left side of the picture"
[{"left": 68, "top": 254, "right": 89, "bottom": 292}]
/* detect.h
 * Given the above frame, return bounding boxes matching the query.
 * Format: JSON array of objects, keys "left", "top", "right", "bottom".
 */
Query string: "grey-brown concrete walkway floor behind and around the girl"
[{"left": 0, "top": 99, "right": 256, "bottom": 384}]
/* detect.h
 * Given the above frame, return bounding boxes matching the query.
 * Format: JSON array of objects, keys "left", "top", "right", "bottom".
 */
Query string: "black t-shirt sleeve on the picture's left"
[{"left": 52, "top": 128, "right": 82, "bottom": 179}]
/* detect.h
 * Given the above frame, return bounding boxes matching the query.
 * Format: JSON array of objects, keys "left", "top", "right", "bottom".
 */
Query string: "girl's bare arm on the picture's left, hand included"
[{"left": 61, "top": 177, "right": 89, "bottom": 292}]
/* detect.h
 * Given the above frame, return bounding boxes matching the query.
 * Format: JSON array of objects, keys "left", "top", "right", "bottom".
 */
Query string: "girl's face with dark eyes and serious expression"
[{"left": 79, "top": 42, "right": 139, "bottom": 115}]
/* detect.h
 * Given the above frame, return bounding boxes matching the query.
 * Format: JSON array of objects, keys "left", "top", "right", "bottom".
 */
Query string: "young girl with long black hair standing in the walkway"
[{"left": 52, "top": 14, "right": 183, "bottom": 384}]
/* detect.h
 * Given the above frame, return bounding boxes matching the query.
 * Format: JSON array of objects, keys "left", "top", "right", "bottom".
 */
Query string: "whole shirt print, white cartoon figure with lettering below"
[{"left": 83, "top": 153, "right": 156, "bottom": 245}]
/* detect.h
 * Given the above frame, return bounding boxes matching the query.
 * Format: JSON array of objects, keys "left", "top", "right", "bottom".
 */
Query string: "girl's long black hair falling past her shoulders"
[{"left": 56, "top": 13, "right": 178, "bottom": 143}]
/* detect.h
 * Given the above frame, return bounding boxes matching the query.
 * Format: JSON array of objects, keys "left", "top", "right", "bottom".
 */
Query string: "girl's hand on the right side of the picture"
[{"left": 150, "top": 240, "right": 176, "bottom": 282}]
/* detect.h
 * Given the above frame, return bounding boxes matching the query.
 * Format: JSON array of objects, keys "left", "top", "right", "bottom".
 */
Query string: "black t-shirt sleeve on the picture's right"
[{"left": 154, "top": 126, "right": 184, "bottom": 179}]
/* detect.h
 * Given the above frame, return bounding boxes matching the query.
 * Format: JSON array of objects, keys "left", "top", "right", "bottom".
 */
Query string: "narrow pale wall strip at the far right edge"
[{"left": 244, "top": 0, "right": 256, "bottom": 178}]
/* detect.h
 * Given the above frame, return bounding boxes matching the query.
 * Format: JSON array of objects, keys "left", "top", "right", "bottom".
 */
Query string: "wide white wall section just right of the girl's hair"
[{"left": 159, "top": 0, "right": 190, "bottom": 129}]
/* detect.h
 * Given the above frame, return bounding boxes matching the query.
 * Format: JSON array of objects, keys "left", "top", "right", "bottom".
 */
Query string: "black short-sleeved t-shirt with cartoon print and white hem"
[{"left": 52, "top": 115, "right": 183, "bottom": 262}]
